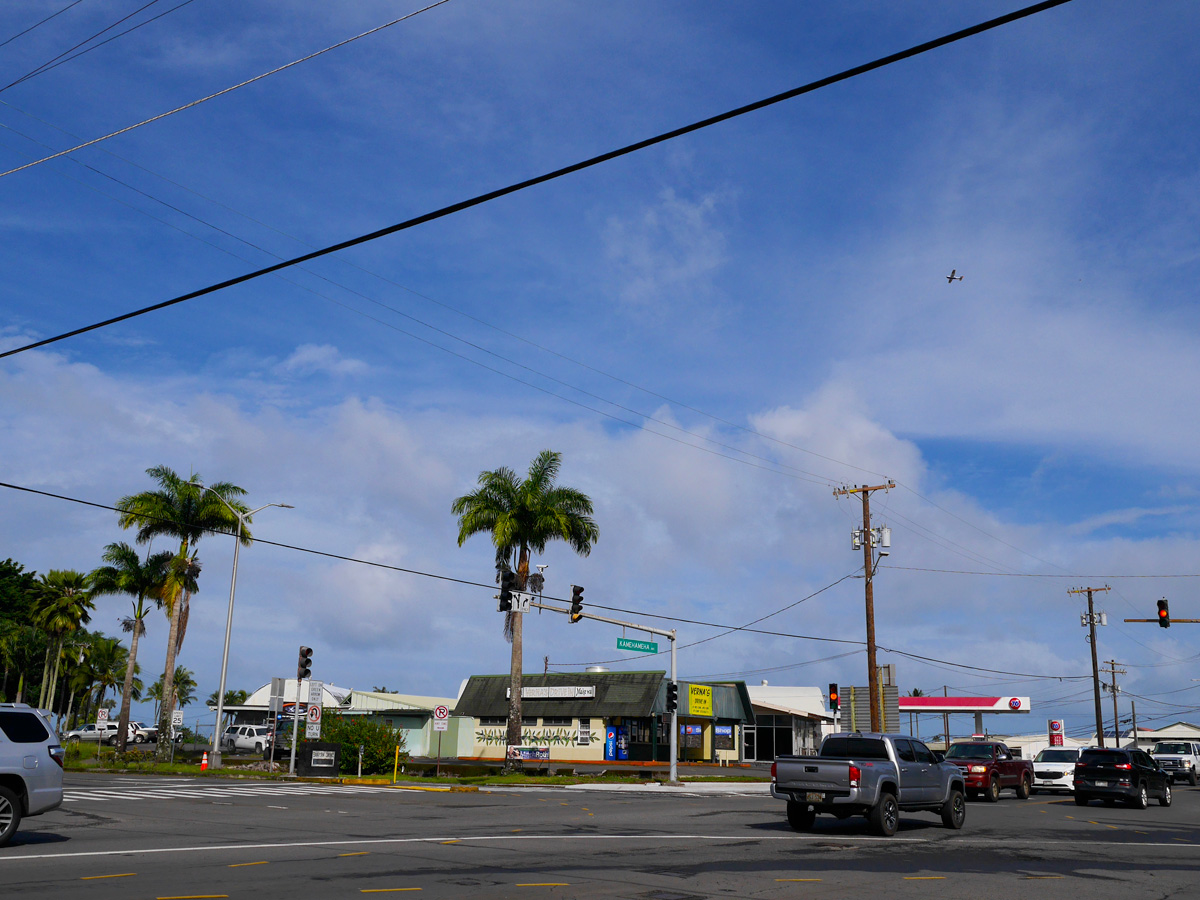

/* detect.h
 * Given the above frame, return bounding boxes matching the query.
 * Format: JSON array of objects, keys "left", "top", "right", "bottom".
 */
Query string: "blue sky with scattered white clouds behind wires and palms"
[{"left": 0, "top": 0, "right": 1200, "bottom": 733}]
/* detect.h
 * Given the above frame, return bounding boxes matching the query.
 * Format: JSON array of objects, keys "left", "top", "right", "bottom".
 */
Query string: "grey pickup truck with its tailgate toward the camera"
[{"left": 770, "top": 732, "right": 967, "bottom": 836}]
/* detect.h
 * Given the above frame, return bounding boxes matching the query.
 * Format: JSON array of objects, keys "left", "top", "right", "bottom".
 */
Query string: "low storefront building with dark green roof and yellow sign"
[{"left": 454, "top": 672, "right": 752, "bottom": 762}]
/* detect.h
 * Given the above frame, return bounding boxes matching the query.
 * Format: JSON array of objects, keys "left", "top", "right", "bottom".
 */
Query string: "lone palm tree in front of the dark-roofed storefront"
[{"left": 450, "top": 450, "right": 600, "bottom": 766}]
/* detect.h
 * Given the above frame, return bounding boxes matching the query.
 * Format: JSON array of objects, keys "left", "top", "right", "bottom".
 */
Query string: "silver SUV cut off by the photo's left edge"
[{"left": 0, "top": 703, "right": 64, "bottom": 847}]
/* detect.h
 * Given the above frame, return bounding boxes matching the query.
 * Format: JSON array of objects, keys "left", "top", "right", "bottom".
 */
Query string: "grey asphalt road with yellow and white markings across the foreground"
[{"left": 0, "top": 774, "right": 1200, "bottom": 900}]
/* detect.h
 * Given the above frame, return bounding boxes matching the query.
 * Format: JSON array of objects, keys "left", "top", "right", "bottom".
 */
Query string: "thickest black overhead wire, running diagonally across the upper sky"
[{"left": 0, "top": 0, "right": 1072, "bottom": 359}]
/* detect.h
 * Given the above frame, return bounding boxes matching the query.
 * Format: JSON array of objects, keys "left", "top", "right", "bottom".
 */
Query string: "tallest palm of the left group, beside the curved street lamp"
[{"left": 116, "top": 466, "right": 252, "bottom": 760}]
